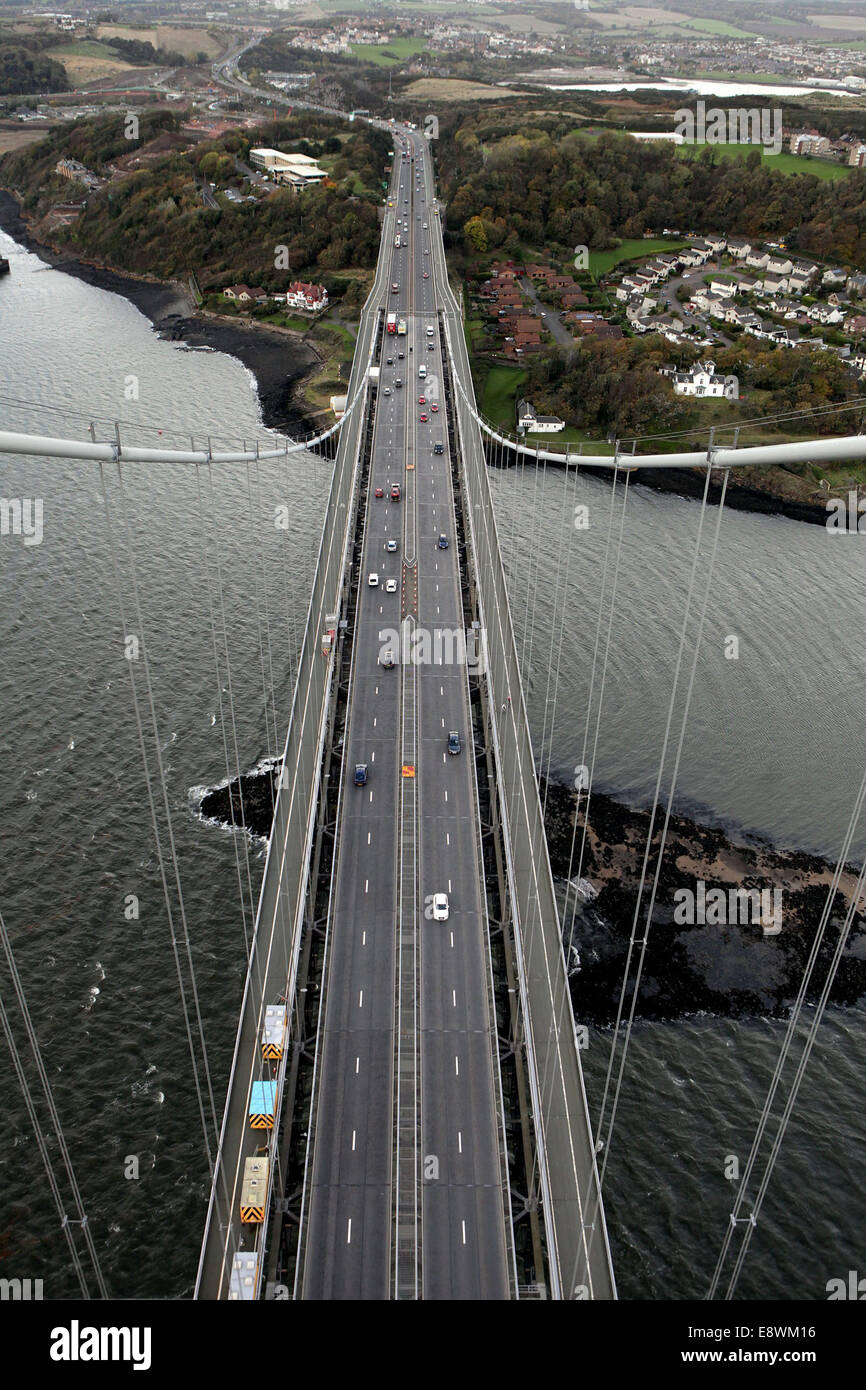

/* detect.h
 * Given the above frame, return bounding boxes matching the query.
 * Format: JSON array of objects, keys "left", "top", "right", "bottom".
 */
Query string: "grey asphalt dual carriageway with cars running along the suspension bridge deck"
[{"left": 296, "top": 133, "right": 514, "bottom": 1300}]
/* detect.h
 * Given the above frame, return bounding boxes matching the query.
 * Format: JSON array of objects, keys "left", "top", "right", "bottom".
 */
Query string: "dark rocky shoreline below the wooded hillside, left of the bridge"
[{"left": 0, "top": 189, "right": 321, "bottom": 436}]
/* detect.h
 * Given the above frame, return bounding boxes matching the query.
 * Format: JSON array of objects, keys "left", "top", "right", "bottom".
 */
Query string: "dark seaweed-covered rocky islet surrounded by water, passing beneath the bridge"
[{"left": 197, "top": 766, "right": 866, "bottom": 1027}]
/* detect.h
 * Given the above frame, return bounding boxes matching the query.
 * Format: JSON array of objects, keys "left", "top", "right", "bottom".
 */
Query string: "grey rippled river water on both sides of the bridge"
[{"left": 0, "top": 227, "right": 866, "bottom": 1298}]
